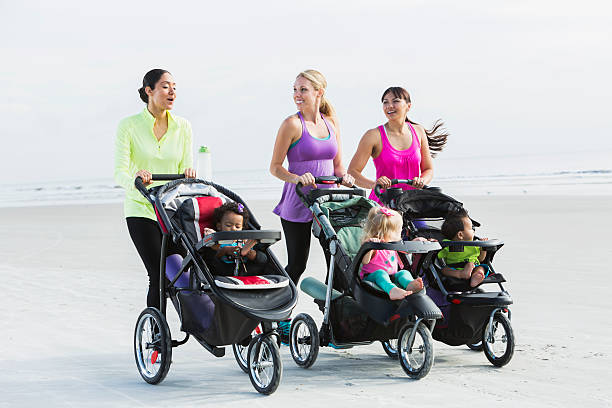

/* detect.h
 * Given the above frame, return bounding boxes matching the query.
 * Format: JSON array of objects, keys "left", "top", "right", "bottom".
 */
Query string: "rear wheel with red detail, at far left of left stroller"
[{"left": 134, "top": 307, "right": 172, "bottom": 384}]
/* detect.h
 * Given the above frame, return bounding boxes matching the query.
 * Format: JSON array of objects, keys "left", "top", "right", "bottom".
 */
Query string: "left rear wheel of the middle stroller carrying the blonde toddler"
[{"left": 289, "top": 313, "right": 319, "bottom": 368}]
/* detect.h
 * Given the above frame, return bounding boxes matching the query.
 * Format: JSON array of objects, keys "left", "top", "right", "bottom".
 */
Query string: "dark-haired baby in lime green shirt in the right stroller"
[{"left": 438, "top": 209, "right": 489, "bottom": 288}]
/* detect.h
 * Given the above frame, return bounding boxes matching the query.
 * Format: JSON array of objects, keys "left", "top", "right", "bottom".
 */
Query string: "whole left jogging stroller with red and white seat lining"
[{"left": 134, "top": 174, "right": 297, "bottom": 394}]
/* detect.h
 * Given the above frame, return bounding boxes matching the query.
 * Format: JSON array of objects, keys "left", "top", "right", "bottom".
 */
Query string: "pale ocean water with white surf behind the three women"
[{"left": 0, "top": 151, "right": 612, "bottom": 207}]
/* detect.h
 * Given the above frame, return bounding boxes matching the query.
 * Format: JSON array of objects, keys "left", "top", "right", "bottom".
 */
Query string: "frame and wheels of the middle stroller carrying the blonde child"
[{"left": 290, "top": 177, "right": 441, "bottom": 379}]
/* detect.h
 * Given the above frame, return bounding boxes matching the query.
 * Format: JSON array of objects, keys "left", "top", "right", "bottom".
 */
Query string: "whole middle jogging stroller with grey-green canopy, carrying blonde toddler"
[{"left": 289, "top": 177, "right": 441, "bottom": 379}]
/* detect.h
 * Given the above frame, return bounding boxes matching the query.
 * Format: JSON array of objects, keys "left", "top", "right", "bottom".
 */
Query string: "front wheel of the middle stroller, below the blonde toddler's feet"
[{"left": 397, "top": 323, "right": 434, "bottom": 380}]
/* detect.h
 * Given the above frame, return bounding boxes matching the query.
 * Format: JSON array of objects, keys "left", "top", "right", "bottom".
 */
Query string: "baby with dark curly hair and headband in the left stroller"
[{"left": 204, "top": 201, "right": 268, "bottom": 275}]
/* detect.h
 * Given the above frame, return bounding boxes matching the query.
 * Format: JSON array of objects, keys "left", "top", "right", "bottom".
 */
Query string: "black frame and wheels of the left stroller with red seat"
[{"left": 134, "top": 174, "right": 297, "bottom": 394}]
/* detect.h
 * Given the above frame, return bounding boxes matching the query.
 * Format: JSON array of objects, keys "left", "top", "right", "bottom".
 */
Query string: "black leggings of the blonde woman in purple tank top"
[{"left": 281, "top": 218, "right": 312, "bottom": 285}]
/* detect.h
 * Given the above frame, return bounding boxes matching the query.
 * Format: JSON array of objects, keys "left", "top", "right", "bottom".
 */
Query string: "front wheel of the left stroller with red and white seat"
[{"left": 247, "top": 335, "right": 283, "bottom": 395}]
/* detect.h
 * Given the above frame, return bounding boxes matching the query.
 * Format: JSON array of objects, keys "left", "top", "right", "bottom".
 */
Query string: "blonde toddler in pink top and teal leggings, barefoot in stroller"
[{"left": 359, "top": 207, "right": 423, "bottom": 300}]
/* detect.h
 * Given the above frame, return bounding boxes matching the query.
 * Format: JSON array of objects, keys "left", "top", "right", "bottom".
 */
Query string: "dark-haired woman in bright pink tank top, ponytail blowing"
[{"left": 348, "top": 87, "right": 448, "bottom": 201}]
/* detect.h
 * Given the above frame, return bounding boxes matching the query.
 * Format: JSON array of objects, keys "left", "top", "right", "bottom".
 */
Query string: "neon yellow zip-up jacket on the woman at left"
[{"left": 115, "top": 108, "right": 193, "bottom": 220}]
